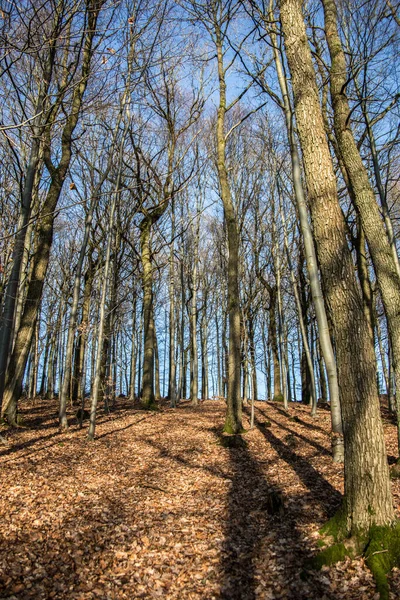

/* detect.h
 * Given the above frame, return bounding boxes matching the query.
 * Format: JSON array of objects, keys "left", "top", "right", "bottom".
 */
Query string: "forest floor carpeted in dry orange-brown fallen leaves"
[{"left": 0, "top": 399, "right": 400, "bottom": 600}]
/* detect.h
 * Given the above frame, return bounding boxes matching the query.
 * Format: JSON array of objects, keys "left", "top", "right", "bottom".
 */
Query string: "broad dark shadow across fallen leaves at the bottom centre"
[{"left": 216, "top": 432, "right": 336, "bottom": 600}]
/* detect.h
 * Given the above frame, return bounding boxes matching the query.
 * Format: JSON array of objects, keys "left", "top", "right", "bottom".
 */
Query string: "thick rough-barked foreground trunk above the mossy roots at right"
[{"left": 280, "top": 0, "right": 394, "bottom": 533}]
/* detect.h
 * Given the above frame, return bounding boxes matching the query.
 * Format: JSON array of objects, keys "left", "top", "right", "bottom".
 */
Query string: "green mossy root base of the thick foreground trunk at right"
[{"left": 304, "top": 511, "right": 400, "bottom": 600}]
